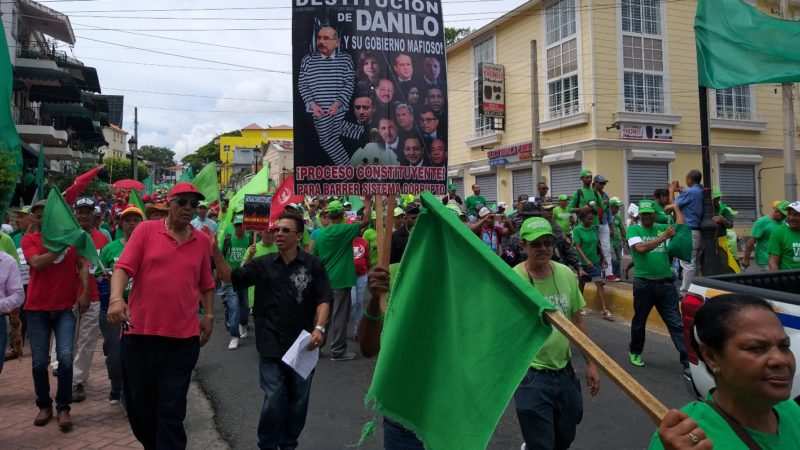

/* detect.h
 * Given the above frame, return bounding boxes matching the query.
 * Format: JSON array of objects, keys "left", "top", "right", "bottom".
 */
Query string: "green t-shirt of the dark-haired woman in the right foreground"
[{"left": 648, "top": 400, "right": 800, "bottom": 450}]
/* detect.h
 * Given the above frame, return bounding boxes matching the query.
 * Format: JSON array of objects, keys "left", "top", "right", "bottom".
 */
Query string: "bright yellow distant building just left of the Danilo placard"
[{"left": 218, "top": 123, "right": 294, "bottom": 186}]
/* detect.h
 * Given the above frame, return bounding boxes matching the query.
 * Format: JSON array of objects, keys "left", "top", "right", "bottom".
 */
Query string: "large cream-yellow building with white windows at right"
[{"left": 447, "top": 0, "right": 800, "bottom": 231}]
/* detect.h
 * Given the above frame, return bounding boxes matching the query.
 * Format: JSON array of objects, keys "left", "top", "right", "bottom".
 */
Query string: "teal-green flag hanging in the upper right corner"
[{"left": 694, "top": 0, "right": 800, "bottom": 89}]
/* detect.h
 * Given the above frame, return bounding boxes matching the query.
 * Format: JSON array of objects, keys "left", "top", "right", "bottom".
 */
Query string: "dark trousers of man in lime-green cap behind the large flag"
[{"left": 514, "top": 365, "right": 583, "bottom": 450}]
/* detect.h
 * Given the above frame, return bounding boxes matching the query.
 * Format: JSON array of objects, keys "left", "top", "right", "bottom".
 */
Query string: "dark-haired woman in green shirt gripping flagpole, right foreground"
[{"left": 649, "top": 294, "right": 800, "bottom": 450}]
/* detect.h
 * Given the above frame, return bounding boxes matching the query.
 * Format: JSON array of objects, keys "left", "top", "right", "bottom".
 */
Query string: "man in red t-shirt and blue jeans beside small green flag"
[{"left": 21, "top": 204, "right": 89, "bottom": 432}]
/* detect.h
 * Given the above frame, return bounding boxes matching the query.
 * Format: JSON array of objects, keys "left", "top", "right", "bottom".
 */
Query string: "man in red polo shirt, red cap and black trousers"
[{"left": 108, "top": 182, "right": 215, "bottom": 449}]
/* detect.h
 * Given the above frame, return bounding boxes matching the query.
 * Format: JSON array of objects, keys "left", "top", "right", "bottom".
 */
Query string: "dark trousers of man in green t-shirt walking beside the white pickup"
[{"left": 630, "top": 278, "right": 689, "bottom": 367}]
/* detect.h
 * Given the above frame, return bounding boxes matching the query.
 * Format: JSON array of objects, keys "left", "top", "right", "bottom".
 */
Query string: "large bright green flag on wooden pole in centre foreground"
[{"left": 367, "top": 193, "right": 554, "bottom": 450}]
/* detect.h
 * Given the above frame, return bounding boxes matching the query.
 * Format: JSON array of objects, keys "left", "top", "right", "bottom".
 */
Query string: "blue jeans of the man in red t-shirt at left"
[{"left": 26, "top": 309, "right": 75, "bottom": 411}]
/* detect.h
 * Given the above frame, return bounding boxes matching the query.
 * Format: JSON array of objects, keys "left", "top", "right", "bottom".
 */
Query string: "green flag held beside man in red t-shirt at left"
[{"left": 42, "top": 189, "right": 103, "bottom": 267}]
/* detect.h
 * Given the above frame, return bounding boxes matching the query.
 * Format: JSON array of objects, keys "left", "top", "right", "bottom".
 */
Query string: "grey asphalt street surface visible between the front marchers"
[{"left": 196, "top": 313, "right": 691, "bottom": 450}]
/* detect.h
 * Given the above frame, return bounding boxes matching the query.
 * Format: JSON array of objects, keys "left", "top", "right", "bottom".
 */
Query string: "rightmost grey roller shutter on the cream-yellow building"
[{"left": 719, "top": 164, "right": 758, "bottom": 224}]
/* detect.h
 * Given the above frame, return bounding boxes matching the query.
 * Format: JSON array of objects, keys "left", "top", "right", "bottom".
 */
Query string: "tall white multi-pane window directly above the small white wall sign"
[{"left": 620, "top": 0, "right": 665, "bottom": 113}]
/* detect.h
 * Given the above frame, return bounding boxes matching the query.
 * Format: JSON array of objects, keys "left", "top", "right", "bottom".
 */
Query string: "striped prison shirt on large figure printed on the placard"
[{"left": 298, "top": 52, "right": 355, "bottom": 112}]
